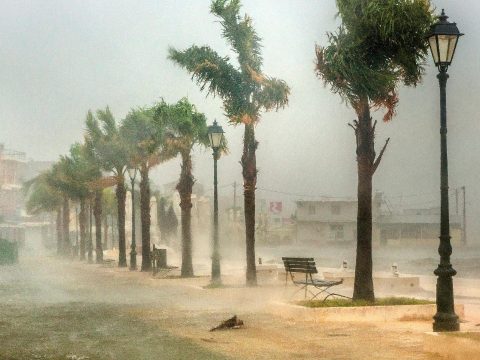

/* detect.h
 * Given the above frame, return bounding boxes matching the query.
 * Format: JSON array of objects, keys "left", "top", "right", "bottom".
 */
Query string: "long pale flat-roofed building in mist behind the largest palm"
[{"left": 297, "top": 193, "right": 462, "bottom": 246}]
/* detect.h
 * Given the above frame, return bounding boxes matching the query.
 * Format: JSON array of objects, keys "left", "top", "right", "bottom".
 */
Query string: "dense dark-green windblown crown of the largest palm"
[{"left": 316, "top": 0, "right": 434, "bottom": 121}]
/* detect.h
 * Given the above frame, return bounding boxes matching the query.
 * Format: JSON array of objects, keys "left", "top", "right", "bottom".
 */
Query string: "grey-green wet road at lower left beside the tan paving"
[{"left": 0, "top": 257, "right": 225, "bottom": 360}]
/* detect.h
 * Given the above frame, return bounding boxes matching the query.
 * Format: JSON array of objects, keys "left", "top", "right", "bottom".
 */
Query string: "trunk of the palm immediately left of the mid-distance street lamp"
[{"left": 177, "top": 152, "right": 195, "bottom": 277}]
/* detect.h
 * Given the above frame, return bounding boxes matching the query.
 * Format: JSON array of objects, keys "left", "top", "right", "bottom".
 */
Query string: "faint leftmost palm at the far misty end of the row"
[{"left": 23, "top": 169, "right": 64, "bottom": 255}]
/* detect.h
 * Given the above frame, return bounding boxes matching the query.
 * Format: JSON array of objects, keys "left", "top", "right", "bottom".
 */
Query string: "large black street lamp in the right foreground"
[{"left": 428, "top": 9, "right": 463, "bottom": 331}]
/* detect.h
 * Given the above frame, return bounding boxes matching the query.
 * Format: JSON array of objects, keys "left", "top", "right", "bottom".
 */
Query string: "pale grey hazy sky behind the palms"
[{"left": 0, "top": 0, "right": 480, "bottom": 242}]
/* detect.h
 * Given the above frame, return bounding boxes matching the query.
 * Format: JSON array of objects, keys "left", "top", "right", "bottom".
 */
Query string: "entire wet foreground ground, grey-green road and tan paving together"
[{"left": 0, "top": 256, "right": 454, "bottom": 360}]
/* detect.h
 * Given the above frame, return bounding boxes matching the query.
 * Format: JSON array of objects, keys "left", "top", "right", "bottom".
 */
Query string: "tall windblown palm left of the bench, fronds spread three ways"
[{"left": 169, "top": 0, "right": 290, "bottom": 286}]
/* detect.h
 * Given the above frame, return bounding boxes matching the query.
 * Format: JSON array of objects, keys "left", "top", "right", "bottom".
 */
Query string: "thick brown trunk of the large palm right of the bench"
[{"left": 353, "top": 100, "right": 375, "bottom": 302}]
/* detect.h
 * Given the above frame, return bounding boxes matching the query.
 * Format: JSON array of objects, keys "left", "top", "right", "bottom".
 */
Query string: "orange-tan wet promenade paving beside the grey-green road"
[{"left": 75, "top": 258, "right": 479, "bottom": 360}]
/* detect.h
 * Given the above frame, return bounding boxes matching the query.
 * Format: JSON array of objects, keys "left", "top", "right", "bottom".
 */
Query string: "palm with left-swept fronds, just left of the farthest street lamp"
[{"left": 86, "top": 106, "right": 128, "bottom": 267}]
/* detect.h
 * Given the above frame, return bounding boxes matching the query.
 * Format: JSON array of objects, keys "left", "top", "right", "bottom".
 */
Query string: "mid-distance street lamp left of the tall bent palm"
[{"left": 208, "top": 120, "right": 223, "bottom": 285}]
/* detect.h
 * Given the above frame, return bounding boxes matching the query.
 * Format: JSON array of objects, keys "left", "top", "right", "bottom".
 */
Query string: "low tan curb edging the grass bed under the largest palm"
[{"left": 269, "top": 302, "right": 465, "bottom": 322}]
